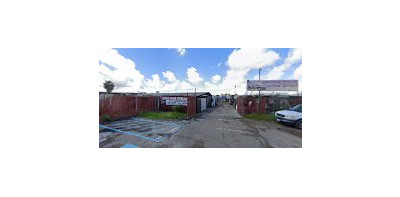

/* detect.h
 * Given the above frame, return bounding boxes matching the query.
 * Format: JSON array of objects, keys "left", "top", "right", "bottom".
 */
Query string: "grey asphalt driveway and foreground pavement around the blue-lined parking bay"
[{"left": 100, "top": 102, "right": 302, "bottom": 148}]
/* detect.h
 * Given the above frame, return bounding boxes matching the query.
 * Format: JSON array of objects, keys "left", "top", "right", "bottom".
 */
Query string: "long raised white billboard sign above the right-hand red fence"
[{"left": 247, "top": 80, "right": 299, "bottom": 91}]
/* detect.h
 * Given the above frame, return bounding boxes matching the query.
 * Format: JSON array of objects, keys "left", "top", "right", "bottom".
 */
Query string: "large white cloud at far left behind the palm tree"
[{"left": 99, "top": 49, "right": 144, "bottom": 92}]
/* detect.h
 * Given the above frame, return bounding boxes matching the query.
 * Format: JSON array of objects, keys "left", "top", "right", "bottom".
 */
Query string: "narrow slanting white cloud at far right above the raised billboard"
[{"left": 264, "top": 49, "right": 302, "bottom": 80}]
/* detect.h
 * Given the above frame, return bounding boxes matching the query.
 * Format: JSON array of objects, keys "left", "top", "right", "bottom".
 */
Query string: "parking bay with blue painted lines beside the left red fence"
[{"left": 100, "top": 117, "right": 185, "bottom": 142}]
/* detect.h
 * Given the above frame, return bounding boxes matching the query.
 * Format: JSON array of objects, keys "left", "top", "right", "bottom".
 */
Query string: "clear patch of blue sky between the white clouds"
[{"left": 116, "top": 48, "right": 233, "bottom": 78}]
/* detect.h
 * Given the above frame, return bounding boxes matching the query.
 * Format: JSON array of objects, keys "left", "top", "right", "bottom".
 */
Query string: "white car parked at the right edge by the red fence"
[{"left": 275, "top": 104, "right": 302, "bottom": 129}]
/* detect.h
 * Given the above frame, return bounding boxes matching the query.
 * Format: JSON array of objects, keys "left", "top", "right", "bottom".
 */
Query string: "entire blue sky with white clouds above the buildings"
[{"left": 99, "top": 48, "right": 302, "bottom": 95}]
